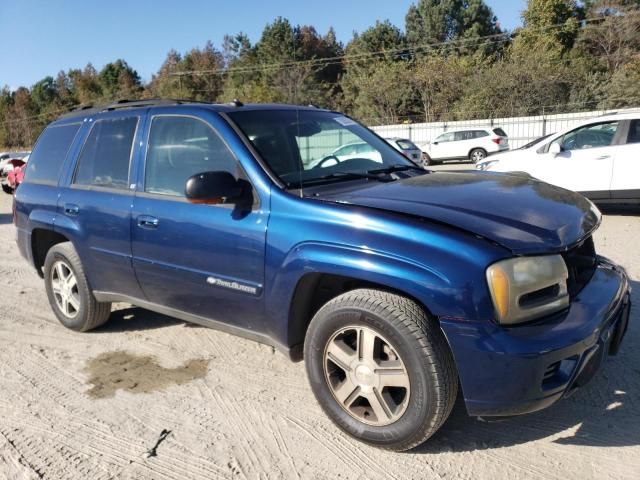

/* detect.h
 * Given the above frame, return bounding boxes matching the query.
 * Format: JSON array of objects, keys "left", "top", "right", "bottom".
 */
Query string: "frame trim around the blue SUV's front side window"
[{"left": 142, "top": 113, "right": 261, "bottom": 210}]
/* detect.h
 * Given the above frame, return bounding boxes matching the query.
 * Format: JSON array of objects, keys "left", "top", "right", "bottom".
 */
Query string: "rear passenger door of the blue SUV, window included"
[{"left": 56, "top": 112, "right": 144, "bottom": 296}]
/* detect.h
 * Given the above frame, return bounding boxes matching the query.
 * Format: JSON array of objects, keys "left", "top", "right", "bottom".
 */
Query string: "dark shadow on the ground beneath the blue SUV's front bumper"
[{"left": 412, "top": 281, "right": 640, "bottom": 454}]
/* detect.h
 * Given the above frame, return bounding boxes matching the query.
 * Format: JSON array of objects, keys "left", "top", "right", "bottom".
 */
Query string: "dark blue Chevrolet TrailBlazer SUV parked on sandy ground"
[{"left": 14, "top": 100, "right": 630, "bottom": 450}]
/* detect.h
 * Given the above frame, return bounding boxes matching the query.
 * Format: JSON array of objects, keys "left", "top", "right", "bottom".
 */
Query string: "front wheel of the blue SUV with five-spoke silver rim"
[{"left": 304, "top": 289, "right": 458, "bottom": 451}]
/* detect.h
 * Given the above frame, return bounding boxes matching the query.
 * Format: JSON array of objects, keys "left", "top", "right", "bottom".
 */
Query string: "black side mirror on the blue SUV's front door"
[{"left": 184, "top": 172, "right": 243, "bottom": 205}]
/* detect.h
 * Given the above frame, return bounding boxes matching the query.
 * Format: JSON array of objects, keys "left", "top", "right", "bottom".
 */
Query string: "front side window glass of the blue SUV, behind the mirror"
[{"left": 144, "top": 116, "right": 239, "bottom": 197}]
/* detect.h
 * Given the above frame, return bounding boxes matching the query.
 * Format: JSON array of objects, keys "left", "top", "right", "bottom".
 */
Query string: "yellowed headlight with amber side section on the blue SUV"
[{"left": 487, "top": 255, "right": 569, "bottom": 325}]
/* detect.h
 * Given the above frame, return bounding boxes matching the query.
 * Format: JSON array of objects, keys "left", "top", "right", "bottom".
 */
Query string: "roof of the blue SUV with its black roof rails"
[{"left": 53, "top": 99, "right": 332, "bottom": 124}]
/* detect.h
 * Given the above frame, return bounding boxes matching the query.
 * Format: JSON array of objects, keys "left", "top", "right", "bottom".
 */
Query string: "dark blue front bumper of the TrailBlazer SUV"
[{"left": 441, "top": 259, "right": 631, "bottom": 416}]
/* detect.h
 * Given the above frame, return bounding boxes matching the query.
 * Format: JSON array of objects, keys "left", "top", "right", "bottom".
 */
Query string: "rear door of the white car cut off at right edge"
[{"left": 611, "top": 119, "right": 640, "bottom": 199}]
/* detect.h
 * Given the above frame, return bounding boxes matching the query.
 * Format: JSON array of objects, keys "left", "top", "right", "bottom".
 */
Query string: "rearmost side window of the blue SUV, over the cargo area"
[{"left": 25, "top": 123, "right": 80, "bottom": 183}]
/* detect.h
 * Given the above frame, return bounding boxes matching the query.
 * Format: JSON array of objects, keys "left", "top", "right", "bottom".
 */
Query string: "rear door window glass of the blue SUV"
[{"left": 74, "top": 117, "right": 138, "bottom": 189}]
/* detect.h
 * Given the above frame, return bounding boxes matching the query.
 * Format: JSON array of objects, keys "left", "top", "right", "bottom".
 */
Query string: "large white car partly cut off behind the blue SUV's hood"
[{"left": 476, "top": 113, "right": 640, "bottom": 203}]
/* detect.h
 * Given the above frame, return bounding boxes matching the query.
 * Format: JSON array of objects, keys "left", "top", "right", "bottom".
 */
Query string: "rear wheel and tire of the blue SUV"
[{"left": 44, "top": 242, "right": 111, "bottom": 332}]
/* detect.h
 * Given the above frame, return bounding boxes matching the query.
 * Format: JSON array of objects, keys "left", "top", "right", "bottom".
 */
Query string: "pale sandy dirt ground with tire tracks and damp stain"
[{"left": 0, "top": 185, "right": 640, "bottom": 480}]
